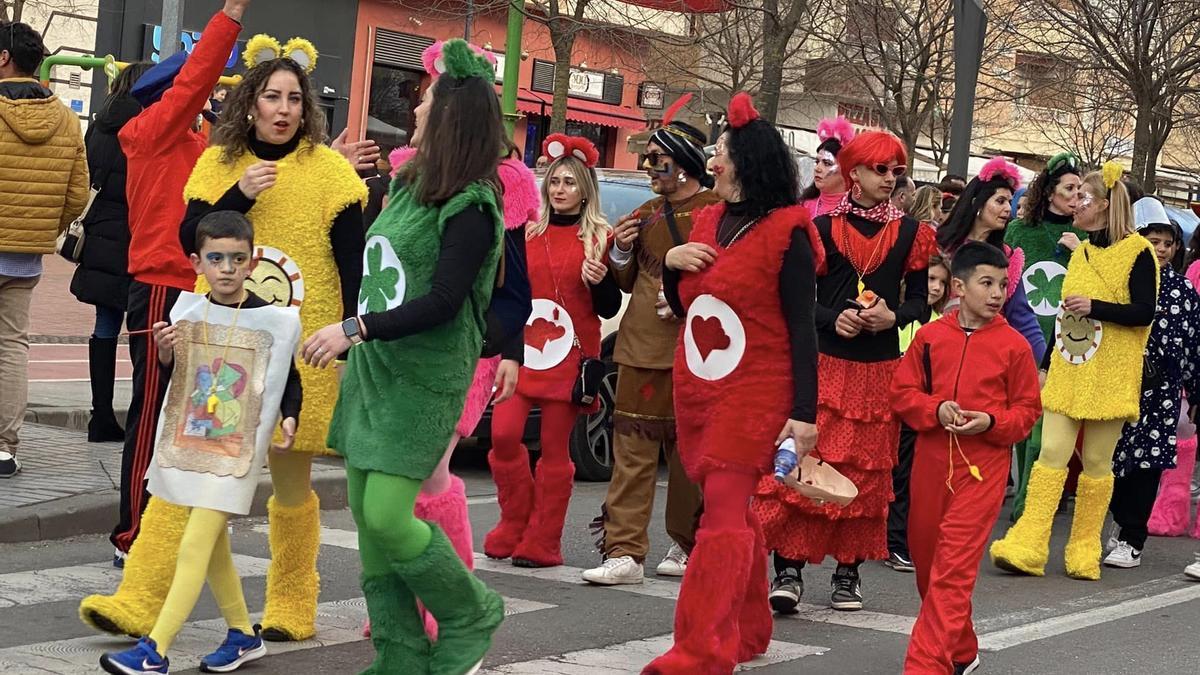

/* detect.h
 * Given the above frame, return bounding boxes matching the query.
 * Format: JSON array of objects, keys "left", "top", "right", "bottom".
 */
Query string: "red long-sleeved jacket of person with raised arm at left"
[{"left": 119, "top": 12, "right": 241, "bottom": 285}]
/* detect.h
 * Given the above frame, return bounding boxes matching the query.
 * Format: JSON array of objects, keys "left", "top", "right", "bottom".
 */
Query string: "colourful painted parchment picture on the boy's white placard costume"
[{"left": 155, "top": 321, "right": 272, "bottom": 477}]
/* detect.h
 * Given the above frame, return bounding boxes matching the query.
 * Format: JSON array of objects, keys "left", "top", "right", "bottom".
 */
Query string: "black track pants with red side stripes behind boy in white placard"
[{"left": 109, "top": 281, "right": 180, "bottom": 551}]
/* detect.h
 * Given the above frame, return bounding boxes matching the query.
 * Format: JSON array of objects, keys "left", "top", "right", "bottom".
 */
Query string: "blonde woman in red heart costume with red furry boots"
[{"left": 484, "top": 135, "right": 620, "bottom": 567}]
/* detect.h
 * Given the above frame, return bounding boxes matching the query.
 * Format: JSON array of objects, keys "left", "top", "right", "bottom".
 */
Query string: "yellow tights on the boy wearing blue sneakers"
[{"left": 150, "top": 508, "right": 254, "bottom": 656}]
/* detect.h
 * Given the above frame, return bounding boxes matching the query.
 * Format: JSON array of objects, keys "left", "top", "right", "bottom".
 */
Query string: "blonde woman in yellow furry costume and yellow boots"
[{"left": 991, "top": 163, "right": 1158, "bottom": 579}]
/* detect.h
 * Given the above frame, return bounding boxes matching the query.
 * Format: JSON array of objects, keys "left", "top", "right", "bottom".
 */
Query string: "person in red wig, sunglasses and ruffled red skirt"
[{"left": 754, "top": 126, "right": 937, "bottom": 613}]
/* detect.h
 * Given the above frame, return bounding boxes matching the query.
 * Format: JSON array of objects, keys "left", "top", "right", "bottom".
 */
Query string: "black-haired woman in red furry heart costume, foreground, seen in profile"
[{"left": 642, "top": 94, "right": 824, "bottom": 675}]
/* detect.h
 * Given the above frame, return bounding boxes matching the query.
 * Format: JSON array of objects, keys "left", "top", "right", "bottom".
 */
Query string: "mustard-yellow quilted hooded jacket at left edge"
[{"left": 0, "top": 78, "right": 88, "bottom": 253}]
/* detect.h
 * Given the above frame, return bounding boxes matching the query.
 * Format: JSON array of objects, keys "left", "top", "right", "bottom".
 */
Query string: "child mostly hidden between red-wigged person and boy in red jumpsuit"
[{"left": 883, "top": 253, "right": 950, "bottom": 572}]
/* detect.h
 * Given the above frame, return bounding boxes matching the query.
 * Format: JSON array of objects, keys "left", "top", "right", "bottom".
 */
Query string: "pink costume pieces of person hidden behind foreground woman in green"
[{"left": 362, "top": 142, "right": 541, "bottom": 639}]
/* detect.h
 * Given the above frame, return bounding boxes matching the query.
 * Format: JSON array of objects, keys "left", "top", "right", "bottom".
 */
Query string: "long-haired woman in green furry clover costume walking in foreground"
[{"left": 304, "top": 40, "right": 504, "bottom": 675}]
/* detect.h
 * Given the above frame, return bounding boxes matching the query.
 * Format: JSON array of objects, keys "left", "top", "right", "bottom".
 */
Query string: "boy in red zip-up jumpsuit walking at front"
[{"left": 892, "top": 243, "right": 1042, "bottom": 675}]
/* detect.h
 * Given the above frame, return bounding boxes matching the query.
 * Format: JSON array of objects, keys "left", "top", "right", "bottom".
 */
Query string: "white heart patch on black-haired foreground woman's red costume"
[{"left": 683, "top": 294, "right": 746, "bottom": 382}]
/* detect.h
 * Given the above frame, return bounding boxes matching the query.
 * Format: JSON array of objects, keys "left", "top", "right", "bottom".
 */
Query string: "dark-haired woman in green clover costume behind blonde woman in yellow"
[{"left": 1004, "top": 153, "right": 1087, "bottom": 514}]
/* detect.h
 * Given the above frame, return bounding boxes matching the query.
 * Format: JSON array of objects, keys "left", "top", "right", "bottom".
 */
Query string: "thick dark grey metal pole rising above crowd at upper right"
[{"left": 949, "top": 0, "right": 988, "bottom": 175}]
